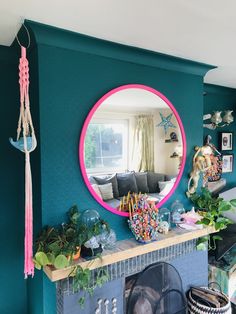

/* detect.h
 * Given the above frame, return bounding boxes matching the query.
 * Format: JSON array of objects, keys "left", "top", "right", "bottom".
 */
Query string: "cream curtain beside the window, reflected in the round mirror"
[{"left": 133, "top": 115, "right": 154, "bottom": 171}]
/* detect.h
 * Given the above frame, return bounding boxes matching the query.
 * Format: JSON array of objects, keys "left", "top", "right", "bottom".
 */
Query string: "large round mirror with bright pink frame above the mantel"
[{"left": 79, "top": 84, "right": 186, "bottom": 216}]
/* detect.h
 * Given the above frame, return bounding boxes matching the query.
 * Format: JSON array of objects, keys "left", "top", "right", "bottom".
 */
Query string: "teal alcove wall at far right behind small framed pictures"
[{"left": 204, "top": 84, "right": 236, "bottom": 189}]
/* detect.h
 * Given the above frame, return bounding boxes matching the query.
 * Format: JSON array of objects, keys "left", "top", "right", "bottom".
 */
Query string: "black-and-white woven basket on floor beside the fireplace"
[{"left": 188, "top": 287, "right": 232, "bottom": 314}]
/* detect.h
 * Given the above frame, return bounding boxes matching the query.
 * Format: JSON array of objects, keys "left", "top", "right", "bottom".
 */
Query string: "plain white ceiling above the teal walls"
[{"left": 0, "top": 0, "right": 236, "bottom": 88}]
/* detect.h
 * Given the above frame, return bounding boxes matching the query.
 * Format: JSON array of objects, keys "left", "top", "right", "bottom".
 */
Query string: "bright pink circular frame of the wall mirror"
[{"left": 79, "top": 84, "right": 186, "bottom": 217}]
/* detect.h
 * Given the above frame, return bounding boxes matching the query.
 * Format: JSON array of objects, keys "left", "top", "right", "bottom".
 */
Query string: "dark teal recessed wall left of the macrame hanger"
[{"left": 0, "top": 46, "right": 27, "bottom": 314}]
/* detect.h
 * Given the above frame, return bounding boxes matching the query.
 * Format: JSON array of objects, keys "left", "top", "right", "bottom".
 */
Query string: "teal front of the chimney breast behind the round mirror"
[{"left": 26, "top": 24, "right": 212, "bottom": 314}]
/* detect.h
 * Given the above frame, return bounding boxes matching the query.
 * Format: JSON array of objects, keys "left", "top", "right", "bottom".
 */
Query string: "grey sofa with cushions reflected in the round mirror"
[{"left": 89, "top": 171, "right": 174, "bottom": 208}]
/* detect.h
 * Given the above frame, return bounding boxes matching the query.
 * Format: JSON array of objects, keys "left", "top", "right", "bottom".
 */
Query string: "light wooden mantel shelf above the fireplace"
[{"left": 44, "top": 227, "right": 215, "bottom": 282}]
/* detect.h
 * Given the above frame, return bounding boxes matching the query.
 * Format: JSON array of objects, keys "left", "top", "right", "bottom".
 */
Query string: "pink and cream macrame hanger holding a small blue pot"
[{"left": 10, "top": 46, "right": 37, "bottom": 278}]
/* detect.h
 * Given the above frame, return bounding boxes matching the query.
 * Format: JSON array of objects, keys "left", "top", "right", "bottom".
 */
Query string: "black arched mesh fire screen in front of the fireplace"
[{"left": 125, "top": 262, "right": 187, "bottom": 314}]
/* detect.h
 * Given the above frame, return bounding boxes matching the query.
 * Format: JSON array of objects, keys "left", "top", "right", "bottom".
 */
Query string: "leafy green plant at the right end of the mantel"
[{"left": 189, "top": 188, "right": 236, "bottom": 250}]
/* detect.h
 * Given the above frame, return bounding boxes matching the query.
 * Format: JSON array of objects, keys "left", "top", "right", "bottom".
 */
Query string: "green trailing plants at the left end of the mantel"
[{"left": 33, "top": 206, "right": 110, "bottom": 307}]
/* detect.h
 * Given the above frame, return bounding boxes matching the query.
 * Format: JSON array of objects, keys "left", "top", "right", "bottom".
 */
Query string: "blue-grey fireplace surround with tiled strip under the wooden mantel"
[{"left": 56, "top": 240, "right": 208, "bottom": 314}]
